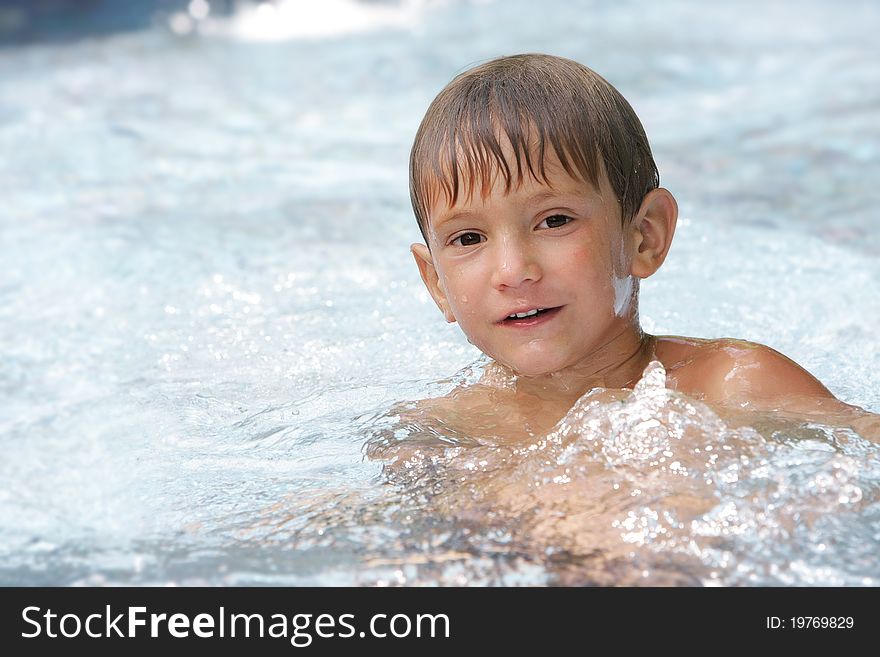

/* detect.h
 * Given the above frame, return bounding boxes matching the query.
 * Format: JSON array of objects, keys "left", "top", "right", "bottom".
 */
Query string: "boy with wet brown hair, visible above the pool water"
[{"left": 402, "top": 54, "right": 880, "bottom": 440}]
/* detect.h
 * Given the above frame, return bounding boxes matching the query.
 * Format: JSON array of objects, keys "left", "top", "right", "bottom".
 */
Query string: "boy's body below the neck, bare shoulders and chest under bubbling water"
[{"left": 367, "top": 335, "right": 880, "bottom": 586}]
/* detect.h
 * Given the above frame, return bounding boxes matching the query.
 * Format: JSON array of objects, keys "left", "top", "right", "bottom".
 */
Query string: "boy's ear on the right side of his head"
[{"left": 631, "top": 187, "right": 678, "bottom": 278}]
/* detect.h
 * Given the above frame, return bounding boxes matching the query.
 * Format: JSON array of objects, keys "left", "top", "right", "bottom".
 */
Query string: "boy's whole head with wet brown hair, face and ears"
[{"left": 410, "top": 55, "right": 677, "bottom": 375}]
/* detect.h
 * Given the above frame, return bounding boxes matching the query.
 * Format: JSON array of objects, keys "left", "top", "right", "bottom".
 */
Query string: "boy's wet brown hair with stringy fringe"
[{"left": 409, "top": 54, "right": 660, "bottom": 243}]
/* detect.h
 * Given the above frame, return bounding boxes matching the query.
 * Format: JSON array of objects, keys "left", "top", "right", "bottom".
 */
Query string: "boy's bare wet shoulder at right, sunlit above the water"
[{"left": 656, "top": 336, "right": 834, "bottom": 408}]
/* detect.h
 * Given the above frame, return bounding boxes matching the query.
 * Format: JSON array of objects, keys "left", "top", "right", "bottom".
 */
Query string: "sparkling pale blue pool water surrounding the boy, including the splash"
[{"left": 0, "top": 1, "right": 880, "bottom": 586}]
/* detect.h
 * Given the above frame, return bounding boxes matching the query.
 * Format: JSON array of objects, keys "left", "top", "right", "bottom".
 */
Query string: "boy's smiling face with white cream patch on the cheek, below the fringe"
[{"left": 413, "top": 147, "right": 635, "bottom": 376}]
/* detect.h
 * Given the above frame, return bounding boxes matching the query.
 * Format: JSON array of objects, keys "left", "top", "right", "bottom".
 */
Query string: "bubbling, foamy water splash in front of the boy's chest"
[{"left": 364, "top": 361, "right": 880, "bottom": 585}]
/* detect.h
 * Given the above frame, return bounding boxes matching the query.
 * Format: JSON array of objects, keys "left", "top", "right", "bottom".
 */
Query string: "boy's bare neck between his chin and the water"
[{"left": 499, "top": 323, "right": 655, "bottom": 404}]
